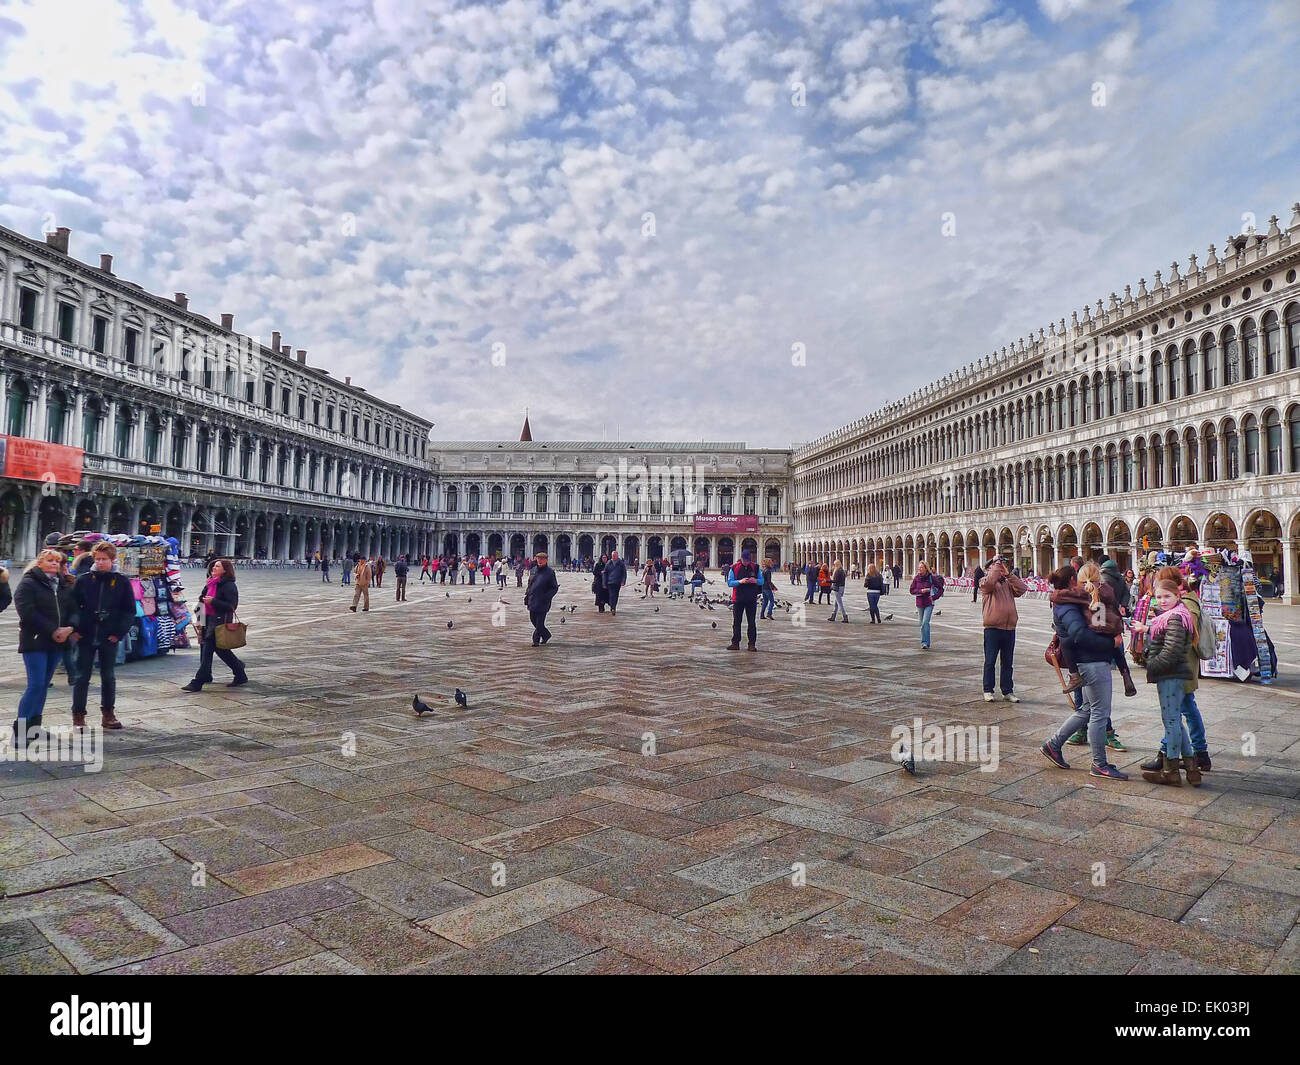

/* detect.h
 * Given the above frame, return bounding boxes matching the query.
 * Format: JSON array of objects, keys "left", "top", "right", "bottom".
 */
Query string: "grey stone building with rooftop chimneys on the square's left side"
[{"left": 0, "top": 228, "right": 436, "bottom": 559}]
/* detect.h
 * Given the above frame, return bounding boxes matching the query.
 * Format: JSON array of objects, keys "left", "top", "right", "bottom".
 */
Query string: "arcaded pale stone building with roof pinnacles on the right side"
[{"left": 792, "top": 204, "right": 1300, "bottom": 601}]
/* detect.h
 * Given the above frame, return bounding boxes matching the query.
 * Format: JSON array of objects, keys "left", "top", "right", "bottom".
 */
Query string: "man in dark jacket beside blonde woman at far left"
[{"left": 73, "top": 542, "right": 135, "bottom": 728}]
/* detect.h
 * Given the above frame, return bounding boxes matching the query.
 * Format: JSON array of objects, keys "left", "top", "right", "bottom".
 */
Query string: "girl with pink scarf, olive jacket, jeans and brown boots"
[{"left": 1141, "top": 580, "right": 1201, "bottom": 788}]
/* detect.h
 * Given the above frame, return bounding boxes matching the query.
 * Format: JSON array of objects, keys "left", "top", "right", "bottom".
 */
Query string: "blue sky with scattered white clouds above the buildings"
[{"left": 0, "top": 0, "right": 1300, "bottom": 446}]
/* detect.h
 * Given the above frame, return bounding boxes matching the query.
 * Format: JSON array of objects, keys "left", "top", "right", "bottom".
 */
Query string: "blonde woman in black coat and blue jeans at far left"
[{"left": 13, "top": 547, "right": 74, "bottom": 739}]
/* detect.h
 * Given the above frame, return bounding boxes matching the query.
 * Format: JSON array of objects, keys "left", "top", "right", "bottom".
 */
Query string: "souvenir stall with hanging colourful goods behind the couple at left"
[{"left": 44, "top": 531, "right": 191, "bottom": 664}]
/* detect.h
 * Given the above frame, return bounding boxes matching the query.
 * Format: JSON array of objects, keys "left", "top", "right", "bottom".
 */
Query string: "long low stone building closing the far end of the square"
[{"left": 436, "top": 421, "right": 792, "bottom": 566}]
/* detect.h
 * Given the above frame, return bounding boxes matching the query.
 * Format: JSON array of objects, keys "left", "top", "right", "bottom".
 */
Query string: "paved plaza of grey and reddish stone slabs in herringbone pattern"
[{"left": 0, "top": 571, "right": 1300, "bottom": 974}]
